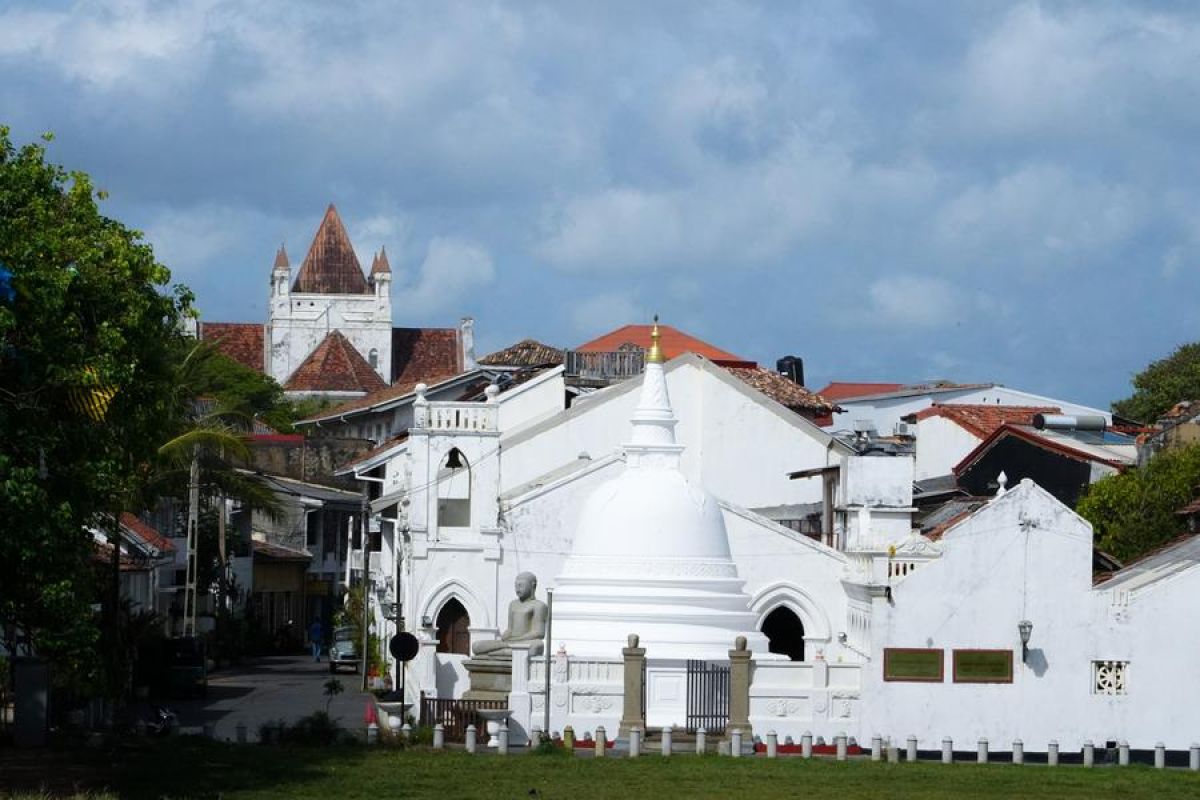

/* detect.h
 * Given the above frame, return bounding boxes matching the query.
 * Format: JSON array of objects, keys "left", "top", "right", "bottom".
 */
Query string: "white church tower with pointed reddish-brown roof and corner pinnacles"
[{"left": 266, "top": 204, "right": 392, "bottom": 397}]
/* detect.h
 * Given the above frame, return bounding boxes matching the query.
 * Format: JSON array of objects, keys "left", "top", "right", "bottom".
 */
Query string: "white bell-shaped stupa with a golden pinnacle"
[{"left": 552, "top": 324, "right": 767, "bottom": 660}]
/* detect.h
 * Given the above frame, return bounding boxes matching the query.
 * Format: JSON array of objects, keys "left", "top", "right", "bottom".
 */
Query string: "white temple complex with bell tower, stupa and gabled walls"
[{"left": 331, "top": 321, "right": 1200, "bottom": 753}]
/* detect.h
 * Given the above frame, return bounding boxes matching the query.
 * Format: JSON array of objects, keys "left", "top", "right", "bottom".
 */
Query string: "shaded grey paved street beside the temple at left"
[{"left": 168, "top": 656, "right": 367, "bottom": 740}]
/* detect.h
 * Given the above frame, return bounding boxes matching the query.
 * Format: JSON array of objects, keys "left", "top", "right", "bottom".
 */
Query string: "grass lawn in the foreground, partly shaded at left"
[{"left": 0, "top": 738, "right": 1200, "bottom": 800}]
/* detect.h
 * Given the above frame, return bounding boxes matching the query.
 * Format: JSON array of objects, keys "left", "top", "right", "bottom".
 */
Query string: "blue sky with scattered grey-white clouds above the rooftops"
[{"left": 0, "top": 0, "right": 1200, "bottom": 405}]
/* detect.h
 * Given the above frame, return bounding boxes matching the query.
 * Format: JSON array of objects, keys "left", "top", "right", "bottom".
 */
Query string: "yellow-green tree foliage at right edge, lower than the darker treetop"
[{"left": 1076, "top": 445, "right": 1200, "bottom": 560}]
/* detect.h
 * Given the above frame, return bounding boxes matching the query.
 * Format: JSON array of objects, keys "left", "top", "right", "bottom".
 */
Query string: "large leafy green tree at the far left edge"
[{"left": 0, "top": 127, "right": 191, "bottom": 669}]
